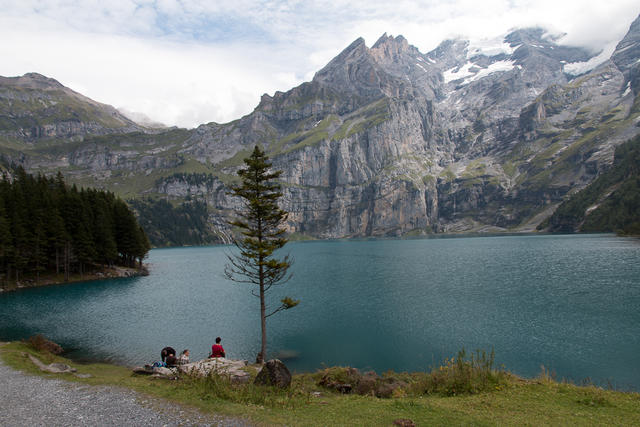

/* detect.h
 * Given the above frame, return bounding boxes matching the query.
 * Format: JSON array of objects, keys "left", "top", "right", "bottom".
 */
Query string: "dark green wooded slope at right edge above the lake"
[{"left": 539, "top": 136, "right": 640, "bottom": 235}]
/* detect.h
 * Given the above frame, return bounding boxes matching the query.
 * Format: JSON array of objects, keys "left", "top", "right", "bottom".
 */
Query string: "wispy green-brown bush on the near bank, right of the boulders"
[{"left": 410, "top": 349, "right": 508, "bottom": 396}]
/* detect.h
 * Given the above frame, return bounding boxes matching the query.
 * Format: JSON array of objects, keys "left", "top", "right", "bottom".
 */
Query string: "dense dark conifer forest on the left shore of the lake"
[{"left": 0, "top": 168, "right": 150, "bottom": 282}]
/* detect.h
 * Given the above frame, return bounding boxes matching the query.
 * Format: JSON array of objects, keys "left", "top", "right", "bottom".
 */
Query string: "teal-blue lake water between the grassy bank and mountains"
[{"left": 0, "top": 235, "right": 640, "bottom": 390}]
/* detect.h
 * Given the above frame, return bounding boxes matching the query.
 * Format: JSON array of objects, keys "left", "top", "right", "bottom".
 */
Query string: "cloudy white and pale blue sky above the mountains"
[{"left": 0, "top": 0, "right": 640, "bottom": 128}]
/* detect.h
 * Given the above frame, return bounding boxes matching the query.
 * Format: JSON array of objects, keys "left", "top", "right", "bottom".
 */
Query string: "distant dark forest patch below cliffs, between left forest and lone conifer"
[{"left": 129, "top": 197, "right": 221, "bottom": 247}]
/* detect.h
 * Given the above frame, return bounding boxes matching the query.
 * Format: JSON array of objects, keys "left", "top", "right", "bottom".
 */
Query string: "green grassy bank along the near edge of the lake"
[{"left": 0, "top": 342, "right": 640, "bottom": 426}]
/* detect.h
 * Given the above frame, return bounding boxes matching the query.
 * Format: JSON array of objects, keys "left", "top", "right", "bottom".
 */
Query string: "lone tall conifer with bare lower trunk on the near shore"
[{"left": 225, "top": 145, "right": 300, "bottom": 362}]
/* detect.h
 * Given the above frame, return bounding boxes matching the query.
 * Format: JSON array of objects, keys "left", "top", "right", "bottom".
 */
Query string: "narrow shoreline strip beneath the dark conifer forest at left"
[{"left": 0, "top": 264, "right": 149, "bottom": 294}]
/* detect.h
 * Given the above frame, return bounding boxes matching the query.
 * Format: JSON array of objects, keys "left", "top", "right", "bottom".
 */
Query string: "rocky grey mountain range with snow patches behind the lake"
[{"left": 0, "top": 17, "right": 640, "bottom": 245}]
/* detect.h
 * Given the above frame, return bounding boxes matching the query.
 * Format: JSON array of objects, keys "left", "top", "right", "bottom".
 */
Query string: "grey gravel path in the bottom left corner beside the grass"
[{"left": 0, "top": 361, "right": 255, "bottom": 427}]
